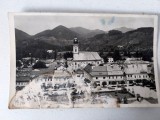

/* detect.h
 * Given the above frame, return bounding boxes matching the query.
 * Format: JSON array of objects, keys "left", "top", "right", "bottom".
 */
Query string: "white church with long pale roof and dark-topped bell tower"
[{"left": 72, "top": 38, "right": 103, "bottom": 70}]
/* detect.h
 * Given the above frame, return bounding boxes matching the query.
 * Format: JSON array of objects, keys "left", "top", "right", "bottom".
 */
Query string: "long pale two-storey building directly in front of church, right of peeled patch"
[{"left": 84, "top": 64, "right": 125, "bottom": 87}]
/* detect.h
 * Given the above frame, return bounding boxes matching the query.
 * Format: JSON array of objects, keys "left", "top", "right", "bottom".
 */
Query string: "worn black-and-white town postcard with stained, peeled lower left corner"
[{"left": 9, "top": 13, "right": 160, "bottom": 109}]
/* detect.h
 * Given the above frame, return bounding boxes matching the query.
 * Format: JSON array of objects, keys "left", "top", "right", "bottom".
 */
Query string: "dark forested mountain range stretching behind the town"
[{"left": 15, "top": 25, "right": 153, "bottom": 59}]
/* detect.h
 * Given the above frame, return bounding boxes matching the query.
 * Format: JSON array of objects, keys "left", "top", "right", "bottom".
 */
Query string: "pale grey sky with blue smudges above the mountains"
[{"left": 14, "top": 14, "right": 154, "bottom": 35}]
